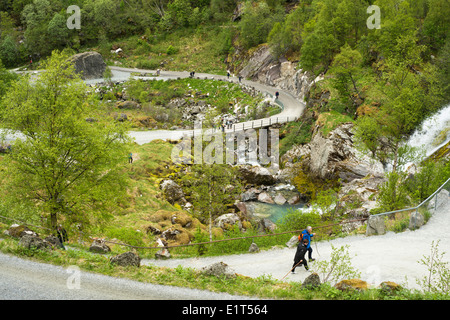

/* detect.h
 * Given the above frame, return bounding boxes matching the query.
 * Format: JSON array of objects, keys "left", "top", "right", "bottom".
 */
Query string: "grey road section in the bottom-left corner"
[{"left": 0, "top": 254, "right": 253, "bottom": 300}]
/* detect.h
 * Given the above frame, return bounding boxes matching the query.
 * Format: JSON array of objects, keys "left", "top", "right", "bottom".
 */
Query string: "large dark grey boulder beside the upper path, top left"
[{"left": 71, "top": 51, "right": 107, "bottom": 80}]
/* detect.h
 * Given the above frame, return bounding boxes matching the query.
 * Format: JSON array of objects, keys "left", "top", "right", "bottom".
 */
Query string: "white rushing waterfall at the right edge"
[{"left": 407, "top": 104, "right": 450, "bottom": 157}]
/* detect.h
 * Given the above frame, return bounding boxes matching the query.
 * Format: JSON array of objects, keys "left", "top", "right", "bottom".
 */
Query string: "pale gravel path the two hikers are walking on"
[{"left": 143, "top": 199, "right": 450, "bottom": 289}]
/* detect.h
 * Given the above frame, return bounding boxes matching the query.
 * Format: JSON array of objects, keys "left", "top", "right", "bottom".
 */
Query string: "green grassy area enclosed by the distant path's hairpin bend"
[{"left": 93, "top": 78, "right": 266, "bottom": 130}]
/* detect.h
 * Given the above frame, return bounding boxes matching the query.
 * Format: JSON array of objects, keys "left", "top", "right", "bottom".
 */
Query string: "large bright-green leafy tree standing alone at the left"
[{"left": 0, "top": 52, "right": 128, "bottom": 228}]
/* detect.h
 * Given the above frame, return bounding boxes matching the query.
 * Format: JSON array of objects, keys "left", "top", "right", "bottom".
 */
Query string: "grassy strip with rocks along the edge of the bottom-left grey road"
[{"left": 0, "top": 238, "right": 449, "bottom": 300}]
